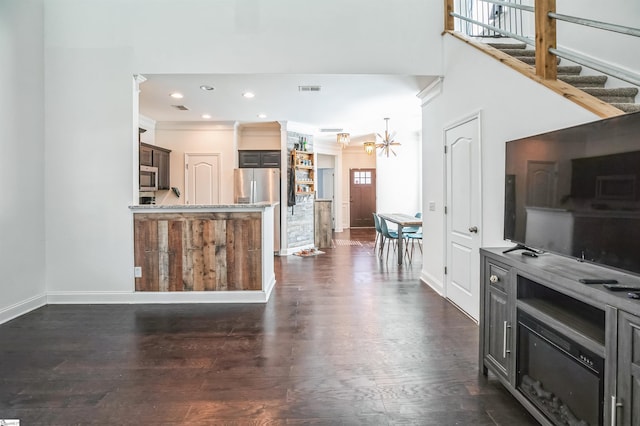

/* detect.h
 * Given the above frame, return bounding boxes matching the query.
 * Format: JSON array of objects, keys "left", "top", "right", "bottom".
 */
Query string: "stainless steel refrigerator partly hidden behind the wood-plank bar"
[{"left": 233, "top": 169, "right": 280, "bottom": 253}]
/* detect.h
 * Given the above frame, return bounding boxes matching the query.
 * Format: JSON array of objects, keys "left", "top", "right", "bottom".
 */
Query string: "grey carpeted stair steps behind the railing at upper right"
[{"left": 488, "top": 43, "right": 640, "bottom": 113}]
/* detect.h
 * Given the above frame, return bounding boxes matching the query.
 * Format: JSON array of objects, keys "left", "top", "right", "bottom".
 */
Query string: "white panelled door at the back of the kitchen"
[{"left": 184, "top": 154, "right": 220, "bottom": 205}]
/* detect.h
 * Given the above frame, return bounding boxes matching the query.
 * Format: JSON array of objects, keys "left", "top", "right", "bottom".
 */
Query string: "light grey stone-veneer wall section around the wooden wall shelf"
[{"left": 282, "top": 132, "right": 314, "bottom": 249}]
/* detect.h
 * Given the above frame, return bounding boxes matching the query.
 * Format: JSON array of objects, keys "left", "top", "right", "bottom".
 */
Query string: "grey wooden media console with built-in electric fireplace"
[{"left": 480, "top": 248, "right": 640, "bottom": 425}]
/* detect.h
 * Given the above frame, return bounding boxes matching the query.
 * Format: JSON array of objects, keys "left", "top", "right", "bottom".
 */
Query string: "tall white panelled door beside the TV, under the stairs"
[{"left": 445, "top": 115, "right": 482, "bottom": 321}]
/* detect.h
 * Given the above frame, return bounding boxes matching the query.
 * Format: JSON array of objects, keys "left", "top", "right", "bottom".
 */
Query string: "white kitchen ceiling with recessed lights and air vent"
[{"left": 140, "top": 74, "right": 434, "bottom": 139}]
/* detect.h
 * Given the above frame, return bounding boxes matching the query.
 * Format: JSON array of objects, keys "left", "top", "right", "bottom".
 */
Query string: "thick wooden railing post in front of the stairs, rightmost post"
[{"left": 535, "top": 0, "right": 558, "bottom": 80}]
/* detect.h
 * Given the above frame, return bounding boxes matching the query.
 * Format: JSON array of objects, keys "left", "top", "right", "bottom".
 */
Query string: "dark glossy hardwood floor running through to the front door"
[{"left": 0, "top": 230, "right": 537, "bottom": 426}]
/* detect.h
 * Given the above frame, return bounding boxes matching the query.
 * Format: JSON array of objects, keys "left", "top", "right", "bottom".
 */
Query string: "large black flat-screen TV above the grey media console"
[{"left": 504, "top": 113, "right": 640, "bottom": 274}]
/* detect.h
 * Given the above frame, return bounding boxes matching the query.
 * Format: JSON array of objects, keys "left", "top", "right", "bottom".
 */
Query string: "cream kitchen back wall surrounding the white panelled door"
[{"left": 155, "top": 123, "right": 236, "bottom": 204}]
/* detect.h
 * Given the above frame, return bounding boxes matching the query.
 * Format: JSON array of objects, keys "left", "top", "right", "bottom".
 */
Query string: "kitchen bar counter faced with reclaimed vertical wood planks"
[{"left": 131, "top": 203, "right": 277, "bottom": 303}]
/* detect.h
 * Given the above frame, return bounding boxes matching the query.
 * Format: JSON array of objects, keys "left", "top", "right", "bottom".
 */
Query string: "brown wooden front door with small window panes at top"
[{"left": 349, "top": 169, "right": 376, "bottom": 228}]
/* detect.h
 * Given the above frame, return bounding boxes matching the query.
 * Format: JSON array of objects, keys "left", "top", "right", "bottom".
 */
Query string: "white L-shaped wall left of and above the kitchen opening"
[{"left": 38, "top": 0, "right": 442, "bottom": 301}]
